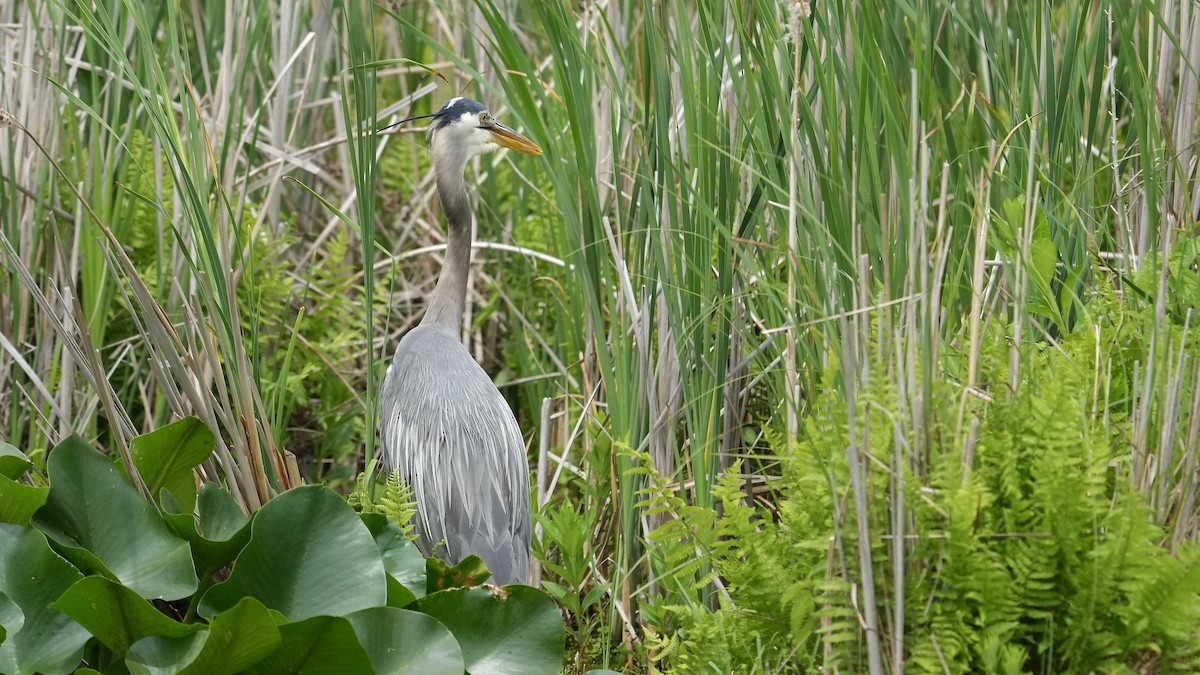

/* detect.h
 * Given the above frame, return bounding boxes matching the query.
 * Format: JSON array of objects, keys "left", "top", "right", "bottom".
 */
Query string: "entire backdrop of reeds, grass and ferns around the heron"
[{"left": 0, "top": 0, "right": 1200, "bottom": 673}]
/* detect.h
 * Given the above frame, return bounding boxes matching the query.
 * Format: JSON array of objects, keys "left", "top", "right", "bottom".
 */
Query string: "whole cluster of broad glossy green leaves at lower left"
[{"left": 0, "top": 418, "right": 564, "bottom": 675}]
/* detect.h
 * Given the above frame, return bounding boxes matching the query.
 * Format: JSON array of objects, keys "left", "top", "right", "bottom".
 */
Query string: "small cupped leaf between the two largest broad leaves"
[{"left": 163, "top": 483, "right": 250, "bottom": 578}]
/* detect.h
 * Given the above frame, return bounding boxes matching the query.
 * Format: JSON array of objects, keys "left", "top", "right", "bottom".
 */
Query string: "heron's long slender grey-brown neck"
[{"left": 421, "top": 172, "right": 470, "bottom": 336}]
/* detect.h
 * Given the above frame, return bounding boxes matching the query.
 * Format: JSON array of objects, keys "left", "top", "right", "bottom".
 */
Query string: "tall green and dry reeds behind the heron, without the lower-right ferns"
[{"left": 0, "top": 0, "right": 1200, "bottom": 671}]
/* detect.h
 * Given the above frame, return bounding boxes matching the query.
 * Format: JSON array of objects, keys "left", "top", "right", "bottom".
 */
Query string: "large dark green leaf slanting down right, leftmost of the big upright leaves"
[{"left": 34, "top": 436, "right": 196, "bottom": 601}]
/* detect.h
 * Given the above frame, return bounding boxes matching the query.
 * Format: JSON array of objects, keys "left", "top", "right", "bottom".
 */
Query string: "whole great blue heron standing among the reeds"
[{"left": 379, "top": 97, "right": 541, "bottom": 585}]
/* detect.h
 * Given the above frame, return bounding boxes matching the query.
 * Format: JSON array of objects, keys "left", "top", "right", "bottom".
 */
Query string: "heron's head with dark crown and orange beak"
[{"left": 430, "top": 96, "right": 541, "bottom": 160}]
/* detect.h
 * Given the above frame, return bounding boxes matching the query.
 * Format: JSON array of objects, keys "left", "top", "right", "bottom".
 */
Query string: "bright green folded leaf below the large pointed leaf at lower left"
[{"left": 50, "top": 577, "right": 200, "bottom": 656}]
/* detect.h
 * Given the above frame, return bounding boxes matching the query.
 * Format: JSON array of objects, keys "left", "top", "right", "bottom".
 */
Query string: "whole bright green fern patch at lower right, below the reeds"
[{"left": 638, "top": 300, "right": 1200, "bottom": 673}]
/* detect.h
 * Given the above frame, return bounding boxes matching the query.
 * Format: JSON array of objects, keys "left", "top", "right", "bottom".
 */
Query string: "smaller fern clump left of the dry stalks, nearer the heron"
[{"left": 643, "top": 427, "right": 857, "bottom": 673}]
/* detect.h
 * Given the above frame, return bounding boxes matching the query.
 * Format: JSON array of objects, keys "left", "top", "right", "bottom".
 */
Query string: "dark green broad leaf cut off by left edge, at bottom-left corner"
[{"left": 0, "top": 524, "right": 88, "bottom": 675}]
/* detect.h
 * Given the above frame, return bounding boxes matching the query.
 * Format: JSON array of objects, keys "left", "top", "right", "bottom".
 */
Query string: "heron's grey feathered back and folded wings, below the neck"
[{"left": 379, "top": 325, "right": 530, "bottom": 585}]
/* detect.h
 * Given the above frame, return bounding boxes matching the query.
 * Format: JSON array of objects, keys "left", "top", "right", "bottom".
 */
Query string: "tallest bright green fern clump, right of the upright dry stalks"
[{"left": 907, "top": 352, "right": 1200, "bottom": 671}]
